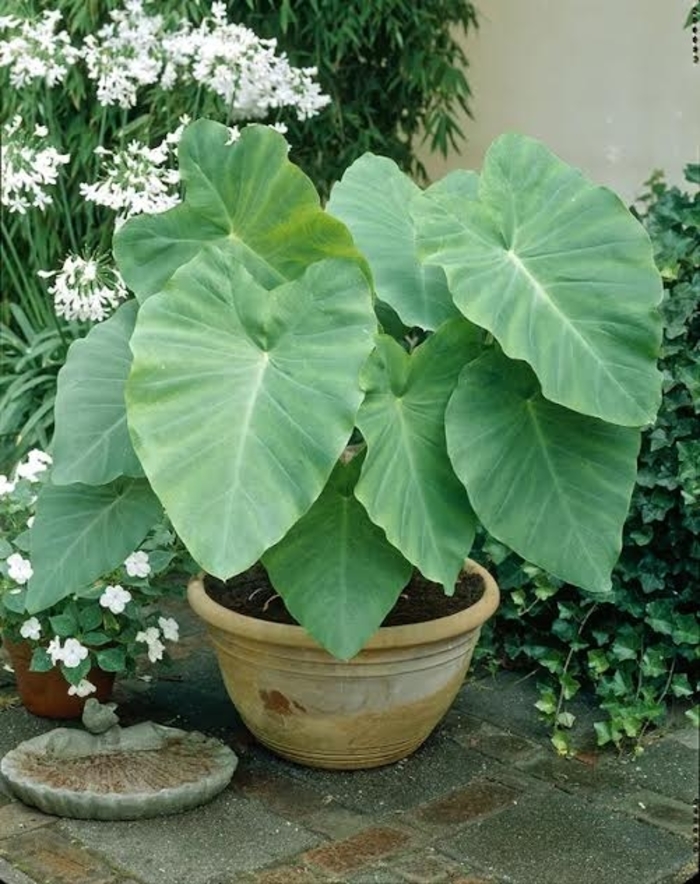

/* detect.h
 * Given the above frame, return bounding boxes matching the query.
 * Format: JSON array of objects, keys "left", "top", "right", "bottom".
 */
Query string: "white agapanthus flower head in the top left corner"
[{"left": 0, "top": 9, "right": 81, "bottom": 88}]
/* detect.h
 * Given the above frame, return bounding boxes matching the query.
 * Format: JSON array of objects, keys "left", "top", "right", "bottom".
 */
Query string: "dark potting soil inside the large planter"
[{"left": 204, "top": 564, "right": 484, "bottom": 626}]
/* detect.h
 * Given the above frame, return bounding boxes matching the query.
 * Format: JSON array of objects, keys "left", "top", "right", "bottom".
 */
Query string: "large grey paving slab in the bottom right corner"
[{"left": 435, "top": 789, "right": 692, "bottom": 884}]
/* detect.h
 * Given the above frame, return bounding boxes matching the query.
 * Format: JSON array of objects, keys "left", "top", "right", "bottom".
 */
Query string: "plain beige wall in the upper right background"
[{"left": 424, "top": 0, "right": 700, "bottom": 202}]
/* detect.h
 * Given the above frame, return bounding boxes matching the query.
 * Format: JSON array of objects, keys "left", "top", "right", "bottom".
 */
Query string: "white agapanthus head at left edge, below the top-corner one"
[{"left": 0, "top": 116, "right": 70, "bottom": 215}]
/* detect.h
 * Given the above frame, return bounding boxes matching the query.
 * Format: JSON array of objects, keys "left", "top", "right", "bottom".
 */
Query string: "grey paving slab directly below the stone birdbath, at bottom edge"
[{"left": 60, "top": 788, "right": 322, "bottom": 884}]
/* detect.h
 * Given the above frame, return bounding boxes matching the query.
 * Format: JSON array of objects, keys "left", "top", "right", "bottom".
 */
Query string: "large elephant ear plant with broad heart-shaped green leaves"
[{"left": 28, "top": 120, "right": 662, "bottom": 658}]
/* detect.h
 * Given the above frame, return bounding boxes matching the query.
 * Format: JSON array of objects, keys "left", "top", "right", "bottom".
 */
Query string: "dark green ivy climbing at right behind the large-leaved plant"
[{"left": 479, "top": 165, "right": 700, "bottom": 752}]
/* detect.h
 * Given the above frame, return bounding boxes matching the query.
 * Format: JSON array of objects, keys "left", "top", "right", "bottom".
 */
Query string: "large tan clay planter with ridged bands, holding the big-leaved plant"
[{"left": 188, "top": 561, "right": 499, "bottom": 770}]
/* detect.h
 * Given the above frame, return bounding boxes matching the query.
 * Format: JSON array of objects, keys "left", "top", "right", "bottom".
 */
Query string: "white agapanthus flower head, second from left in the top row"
[{"left": 82, "top": 0, "right": 164, "bottom": 108}]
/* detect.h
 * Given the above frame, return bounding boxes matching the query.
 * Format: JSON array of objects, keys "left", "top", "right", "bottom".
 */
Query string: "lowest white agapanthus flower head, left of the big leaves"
[{"left": 39, "top": 255, "right": 127, "bottom": 322}]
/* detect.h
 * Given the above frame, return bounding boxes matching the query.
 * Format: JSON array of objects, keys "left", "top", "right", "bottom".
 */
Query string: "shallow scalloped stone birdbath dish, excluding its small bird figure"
[{"left": 0, "top": 721, "right": 238, "bottom": 820}]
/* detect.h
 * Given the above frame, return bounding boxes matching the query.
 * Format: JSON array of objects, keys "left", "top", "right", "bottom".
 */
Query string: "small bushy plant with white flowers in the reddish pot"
[{"left": 0, "top": 449, "right": 182, "bottom": 697}]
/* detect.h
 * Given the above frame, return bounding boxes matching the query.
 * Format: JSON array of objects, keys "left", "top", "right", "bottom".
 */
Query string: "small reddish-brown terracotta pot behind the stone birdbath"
[{"left": 3, "top": 638, "right": 116, "bottom": 718}]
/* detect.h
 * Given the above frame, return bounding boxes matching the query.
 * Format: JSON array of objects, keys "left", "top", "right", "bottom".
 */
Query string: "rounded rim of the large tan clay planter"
[{"left": 187, "top": 559, "right": 500, "bottom": 651}]
